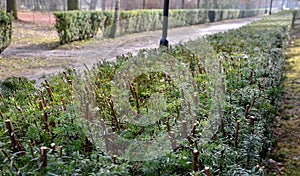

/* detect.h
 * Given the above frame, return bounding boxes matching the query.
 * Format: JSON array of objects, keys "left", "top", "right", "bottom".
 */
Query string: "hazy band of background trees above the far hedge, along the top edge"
[{"left": 4, "top": 0, "right": 299, "bottom": 18}]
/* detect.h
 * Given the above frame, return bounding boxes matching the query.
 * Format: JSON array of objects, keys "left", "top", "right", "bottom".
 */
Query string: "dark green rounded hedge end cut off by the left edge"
[{"left": 0, "top": 11, "right": 13, "bottom": 53}]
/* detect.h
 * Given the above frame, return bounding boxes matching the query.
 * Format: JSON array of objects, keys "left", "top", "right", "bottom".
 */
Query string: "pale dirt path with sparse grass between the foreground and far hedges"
[{"left": 0, "top": 14, "right": 261, "bottom": 80}]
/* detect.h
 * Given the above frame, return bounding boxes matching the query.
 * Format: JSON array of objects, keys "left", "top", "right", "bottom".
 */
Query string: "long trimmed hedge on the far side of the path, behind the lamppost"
[{"left": 54, "top": 9, "right": 264, "bottom": 44}]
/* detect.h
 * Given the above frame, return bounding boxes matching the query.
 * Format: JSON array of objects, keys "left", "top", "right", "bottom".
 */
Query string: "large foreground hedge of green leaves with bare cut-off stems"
[{"left": 0, "top": 11, "right": 295, "bottom": 175}]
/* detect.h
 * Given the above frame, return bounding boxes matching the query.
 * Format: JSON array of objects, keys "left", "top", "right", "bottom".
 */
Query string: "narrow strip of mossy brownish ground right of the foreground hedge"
[{"left": 270, "top": 19, "right": 300, "bottom": 176}]
